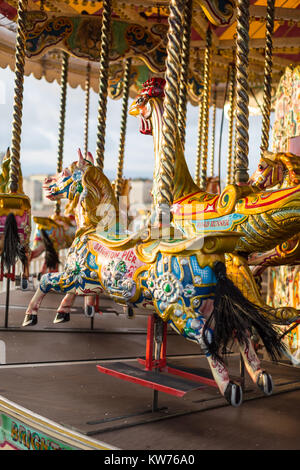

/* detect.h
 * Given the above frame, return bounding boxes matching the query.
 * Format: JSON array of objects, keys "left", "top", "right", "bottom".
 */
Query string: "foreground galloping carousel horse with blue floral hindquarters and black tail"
[{"left": 23, "top": 153, "right": 283, "bottom": 406}]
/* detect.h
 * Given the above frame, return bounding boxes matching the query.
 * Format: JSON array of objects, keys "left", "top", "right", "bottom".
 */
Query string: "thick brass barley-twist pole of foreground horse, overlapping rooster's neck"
[{"left": 154, "top": 0, "right": 183, "bottom": 221}]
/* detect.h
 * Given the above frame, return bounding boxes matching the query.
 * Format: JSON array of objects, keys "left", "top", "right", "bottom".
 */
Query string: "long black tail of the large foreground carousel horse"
[{"left": 203, "top": 261, "right": 285, "bottom": 361}]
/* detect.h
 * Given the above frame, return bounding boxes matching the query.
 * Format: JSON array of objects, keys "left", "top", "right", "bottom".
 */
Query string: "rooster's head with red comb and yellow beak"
[{"left": 129, "top": 77, "right": 166, "bottom": 135}]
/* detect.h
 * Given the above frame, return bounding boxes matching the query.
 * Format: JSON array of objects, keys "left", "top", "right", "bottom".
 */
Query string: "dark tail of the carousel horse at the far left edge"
[{"left": 1, "top": 212, "right": 27, "bottom": 270}]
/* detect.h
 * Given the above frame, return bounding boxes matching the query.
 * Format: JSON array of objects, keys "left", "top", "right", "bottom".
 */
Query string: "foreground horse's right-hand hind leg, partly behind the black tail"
[{"left": 239, "top": 333, "right": 273, "bottom": 395}]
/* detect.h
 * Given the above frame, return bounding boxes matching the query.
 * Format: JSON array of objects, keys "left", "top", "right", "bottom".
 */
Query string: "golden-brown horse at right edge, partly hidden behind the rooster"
[{"left": 248, "top": 151, "right": 300, "bottom": 276}]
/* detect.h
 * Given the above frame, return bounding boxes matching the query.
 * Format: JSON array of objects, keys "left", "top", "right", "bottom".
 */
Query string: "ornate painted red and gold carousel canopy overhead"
[{"left": 0, "top": 0, "right": 300, "bottom": 106}]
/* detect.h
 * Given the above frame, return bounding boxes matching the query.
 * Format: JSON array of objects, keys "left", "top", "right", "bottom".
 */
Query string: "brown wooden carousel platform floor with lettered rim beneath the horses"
[{"left": 0, "top": 284, "right": 300, "bottom": 450}]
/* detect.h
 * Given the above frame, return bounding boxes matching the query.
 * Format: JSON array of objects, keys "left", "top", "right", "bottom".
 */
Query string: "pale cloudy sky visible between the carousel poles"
[{"left": 0, "top": 68, "right": 274, "bottom": 179}]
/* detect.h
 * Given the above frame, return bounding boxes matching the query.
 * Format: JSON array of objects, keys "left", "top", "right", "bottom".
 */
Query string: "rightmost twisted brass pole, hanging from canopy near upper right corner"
[{"left": 261, "top": 0, "right": 275, "bottom": 155}]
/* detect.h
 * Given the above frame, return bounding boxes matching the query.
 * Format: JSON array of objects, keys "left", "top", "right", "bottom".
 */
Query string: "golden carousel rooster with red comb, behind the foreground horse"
[{"left": 129, "top": 78, "right": 300, "bottom": 324}]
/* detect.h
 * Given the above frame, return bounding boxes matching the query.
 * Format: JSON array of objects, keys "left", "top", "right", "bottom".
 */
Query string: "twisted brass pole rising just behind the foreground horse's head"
[{"left": 96, "top": 0, "right": 112, "bottom": 170}]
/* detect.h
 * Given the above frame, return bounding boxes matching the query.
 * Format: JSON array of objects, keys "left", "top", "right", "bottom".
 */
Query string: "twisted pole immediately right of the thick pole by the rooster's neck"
[{"left": 178, "top": 0, "right": 193, "bottom": 149}]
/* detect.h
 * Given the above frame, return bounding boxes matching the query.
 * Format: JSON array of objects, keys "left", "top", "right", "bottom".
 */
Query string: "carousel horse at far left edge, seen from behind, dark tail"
[{"left": 0, "top": 148, "right": 31, "bottom": 289}]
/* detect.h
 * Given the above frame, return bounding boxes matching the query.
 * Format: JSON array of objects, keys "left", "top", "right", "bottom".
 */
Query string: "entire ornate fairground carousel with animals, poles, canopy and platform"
[{"left": 0, "top": 0, "right": 300, "bottom": 450}]
